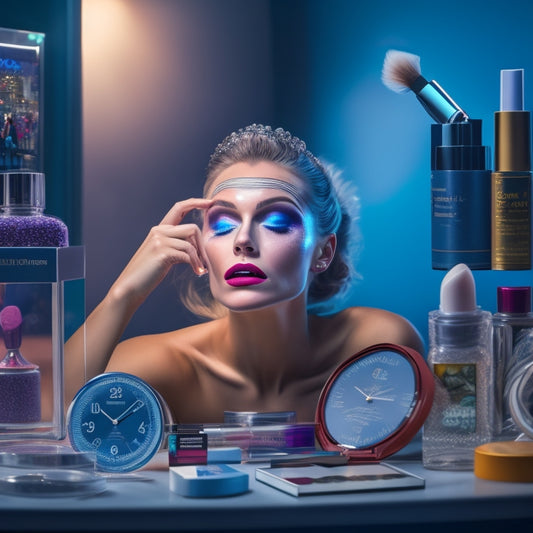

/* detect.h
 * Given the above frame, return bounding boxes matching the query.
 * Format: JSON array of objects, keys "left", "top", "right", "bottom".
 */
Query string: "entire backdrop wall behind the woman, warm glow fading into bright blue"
[{"left": 82, "top": 0, "right": 533, "bottom": 352}]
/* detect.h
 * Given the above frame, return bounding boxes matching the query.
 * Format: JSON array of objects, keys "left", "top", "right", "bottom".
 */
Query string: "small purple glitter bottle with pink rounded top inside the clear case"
[{"left": 0, "top": 305, "right": 41, "bottom": 424}]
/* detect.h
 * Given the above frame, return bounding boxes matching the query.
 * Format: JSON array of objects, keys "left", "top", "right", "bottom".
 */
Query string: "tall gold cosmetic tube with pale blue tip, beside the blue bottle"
[{"left": 491, "top": 69, "right": 531, "bottom": 270}]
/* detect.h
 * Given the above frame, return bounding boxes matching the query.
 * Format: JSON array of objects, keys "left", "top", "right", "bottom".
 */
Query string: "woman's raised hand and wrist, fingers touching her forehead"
[{"left": 113, "top": 198, "right": 213, "bottom": 306}]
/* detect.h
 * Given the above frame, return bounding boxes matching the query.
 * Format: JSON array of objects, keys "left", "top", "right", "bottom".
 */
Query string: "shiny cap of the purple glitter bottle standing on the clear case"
[{"left": 0, "top": 170, "right": 45, "bottom": 210}]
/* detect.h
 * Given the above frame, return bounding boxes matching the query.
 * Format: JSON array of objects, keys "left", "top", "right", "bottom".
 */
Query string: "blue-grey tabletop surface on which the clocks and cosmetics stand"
[{"left": 0, "top": 448, "right": 533, "bottom": 533}]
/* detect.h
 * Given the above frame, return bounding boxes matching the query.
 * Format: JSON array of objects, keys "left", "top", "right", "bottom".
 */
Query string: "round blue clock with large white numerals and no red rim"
[{"left": 67, "top": 372, "right": 165, "bottom": 472}]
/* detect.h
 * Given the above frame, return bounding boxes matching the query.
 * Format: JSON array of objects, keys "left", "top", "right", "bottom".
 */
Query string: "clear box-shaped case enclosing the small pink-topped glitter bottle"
[{"left": 0, "top": 246, "right": 85, "bottom": 443}]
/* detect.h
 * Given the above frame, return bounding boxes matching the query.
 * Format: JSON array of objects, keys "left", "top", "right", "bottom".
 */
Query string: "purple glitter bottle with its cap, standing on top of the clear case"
[{"left": 0, "top": 171, "right": 68, "bottom": 248}]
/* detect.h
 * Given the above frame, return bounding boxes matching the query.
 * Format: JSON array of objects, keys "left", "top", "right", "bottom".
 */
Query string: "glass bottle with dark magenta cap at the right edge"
[{"left": 493, "top": 286, "right": 533, "bottom": 440}]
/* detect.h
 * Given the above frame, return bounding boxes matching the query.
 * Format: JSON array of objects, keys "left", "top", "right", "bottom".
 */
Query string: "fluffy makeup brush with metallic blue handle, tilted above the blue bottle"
[{"left": 381, "top": 50, "right": 468, "bottom": 124}]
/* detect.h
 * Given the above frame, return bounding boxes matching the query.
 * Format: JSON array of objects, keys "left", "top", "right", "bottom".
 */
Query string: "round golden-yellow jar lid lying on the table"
[{"left": 474, "top": 441, "right": 533, "bottom": 483}]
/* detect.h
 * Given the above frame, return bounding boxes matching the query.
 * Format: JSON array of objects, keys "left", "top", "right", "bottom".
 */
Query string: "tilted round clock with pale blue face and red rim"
[{"left": 318, "top": 345, "right": 434, "bottom": 459}]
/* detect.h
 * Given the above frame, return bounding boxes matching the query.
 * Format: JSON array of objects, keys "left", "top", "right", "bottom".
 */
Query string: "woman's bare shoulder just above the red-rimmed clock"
[{"left": 318, "top": 307, "right": 425, "bottom": 354}]
